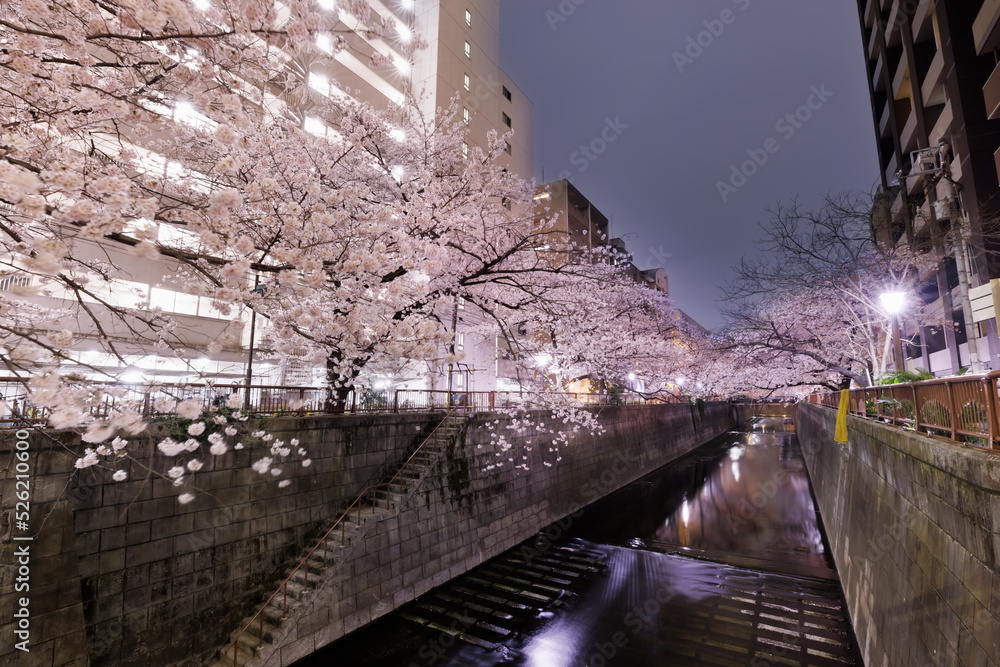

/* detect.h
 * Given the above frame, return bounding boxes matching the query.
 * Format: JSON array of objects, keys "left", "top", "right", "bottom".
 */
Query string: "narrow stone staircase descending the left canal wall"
[{"left": 206, "top": 412, "right": 469, "bottom": 667}]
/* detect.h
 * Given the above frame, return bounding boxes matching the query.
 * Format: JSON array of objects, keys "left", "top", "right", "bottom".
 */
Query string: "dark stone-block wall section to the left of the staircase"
[{"left": 0, "top": 414, "right": 441, "bottom": 666}]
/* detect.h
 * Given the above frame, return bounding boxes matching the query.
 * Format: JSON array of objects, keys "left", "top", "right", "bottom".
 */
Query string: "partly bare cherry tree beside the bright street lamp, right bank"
[{"left": 716, "top": 190, "right": 936, "bottom": 392}]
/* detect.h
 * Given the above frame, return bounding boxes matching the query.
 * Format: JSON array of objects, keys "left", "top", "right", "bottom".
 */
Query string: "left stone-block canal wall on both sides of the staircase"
[{"left": 0, "top": 404, "right": 741, "bottom": 665}]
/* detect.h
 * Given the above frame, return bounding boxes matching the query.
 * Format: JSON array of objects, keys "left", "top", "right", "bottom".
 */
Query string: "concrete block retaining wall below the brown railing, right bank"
[{"left": 796, "top": 404, "right": 1000, "bottom": 667}]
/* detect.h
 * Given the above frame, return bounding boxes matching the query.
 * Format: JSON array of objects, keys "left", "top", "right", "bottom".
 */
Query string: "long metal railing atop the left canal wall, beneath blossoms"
[{"left": 0, "top": 377, "right": 686, "bottom": 428}]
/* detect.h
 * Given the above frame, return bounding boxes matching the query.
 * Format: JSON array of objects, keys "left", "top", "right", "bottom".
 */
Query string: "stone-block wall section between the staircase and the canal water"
[{"left": 264, "top": 404, "right": 747, "bottom": 667}]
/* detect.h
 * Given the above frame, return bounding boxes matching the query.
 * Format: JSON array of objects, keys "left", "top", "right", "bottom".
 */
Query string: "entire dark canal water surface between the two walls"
[{"left": 297, "top": 419, "right": 862, "bottom": 667}]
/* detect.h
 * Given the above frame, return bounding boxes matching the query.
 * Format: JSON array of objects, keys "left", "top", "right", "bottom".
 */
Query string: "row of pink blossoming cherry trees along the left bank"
[{"left": 0, "top": 0, "right": 708, "bottom": 484}]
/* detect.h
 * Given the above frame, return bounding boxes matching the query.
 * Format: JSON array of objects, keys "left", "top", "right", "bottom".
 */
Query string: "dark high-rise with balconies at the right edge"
[{"left": 858, "top": 0, "right": 1000, "bottom": 374}]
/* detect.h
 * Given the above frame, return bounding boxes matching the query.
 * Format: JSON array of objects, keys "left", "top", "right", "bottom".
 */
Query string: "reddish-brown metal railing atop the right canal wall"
[{"left": 809, "top": 371, "right": 1000, "bottom": 450}]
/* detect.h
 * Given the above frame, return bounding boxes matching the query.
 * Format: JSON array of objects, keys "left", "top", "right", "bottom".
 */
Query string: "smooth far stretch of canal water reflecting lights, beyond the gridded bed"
[{"left": 574, "top": 419, "right": 831, "bottom": 576}]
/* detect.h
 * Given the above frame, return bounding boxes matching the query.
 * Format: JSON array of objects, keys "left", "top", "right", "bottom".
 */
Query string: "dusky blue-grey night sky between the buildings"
[{"left": 500, "top": 0, "right": 879, "bottom": 328}]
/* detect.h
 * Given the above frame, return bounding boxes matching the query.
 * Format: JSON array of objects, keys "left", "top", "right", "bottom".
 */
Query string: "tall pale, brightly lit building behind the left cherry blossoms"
[{"left": 7, "top": 0, "right": 533, "bottom": 390}]
